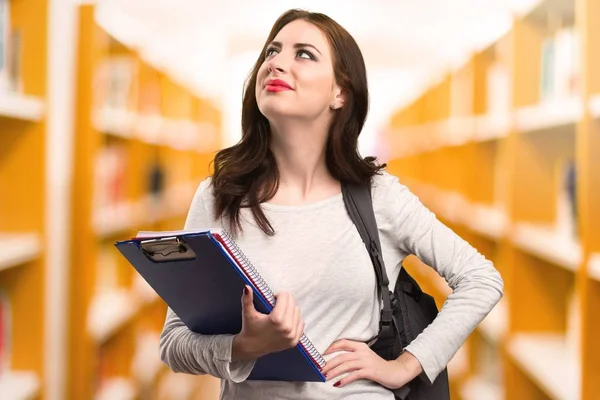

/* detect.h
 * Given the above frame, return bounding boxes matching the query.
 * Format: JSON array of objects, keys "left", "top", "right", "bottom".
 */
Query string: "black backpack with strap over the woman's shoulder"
[{"left": 342, "top": 184, "right": 450, "bottom": 400}]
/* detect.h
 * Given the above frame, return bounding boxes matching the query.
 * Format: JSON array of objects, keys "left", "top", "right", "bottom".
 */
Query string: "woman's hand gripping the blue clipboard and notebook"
[{"left": 231, "top": 286, "right": 304, "bottom": 361}]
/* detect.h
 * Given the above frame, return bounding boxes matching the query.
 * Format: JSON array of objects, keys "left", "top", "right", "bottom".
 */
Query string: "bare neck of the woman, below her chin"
[{"left": 271, "top": 121, "right": 336, "bottom": 202}]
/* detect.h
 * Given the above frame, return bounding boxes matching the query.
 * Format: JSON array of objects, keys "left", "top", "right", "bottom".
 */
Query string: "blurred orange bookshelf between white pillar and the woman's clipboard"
[{"left": 67, "top": 4, "right": 221, "bottom": 400}]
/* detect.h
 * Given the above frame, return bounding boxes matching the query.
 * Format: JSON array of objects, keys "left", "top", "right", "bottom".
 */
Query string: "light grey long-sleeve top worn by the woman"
[{"left": 160, "top": 172, "right": 503, "bottom": 400}]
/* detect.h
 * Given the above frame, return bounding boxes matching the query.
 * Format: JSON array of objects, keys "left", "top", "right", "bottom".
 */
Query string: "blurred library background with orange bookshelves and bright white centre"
[{"left": 0, "top": 0, "right": 600, "bottom": 400}]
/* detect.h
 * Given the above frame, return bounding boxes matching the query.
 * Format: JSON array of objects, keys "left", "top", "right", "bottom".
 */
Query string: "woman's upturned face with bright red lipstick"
[{"left": 256, "top": 20, "right": 342, "bottom": 121}]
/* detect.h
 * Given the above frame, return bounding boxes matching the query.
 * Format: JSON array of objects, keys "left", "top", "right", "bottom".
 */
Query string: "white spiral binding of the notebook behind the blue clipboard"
[{"left": 213, "top": 229, "right": 325, "bottom": 368}]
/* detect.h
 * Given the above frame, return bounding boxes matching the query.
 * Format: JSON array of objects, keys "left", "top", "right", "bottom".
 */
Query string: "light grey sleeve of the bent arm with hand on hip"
[{"left": 385, "top": 177, "right": 504, "bottom": 382}]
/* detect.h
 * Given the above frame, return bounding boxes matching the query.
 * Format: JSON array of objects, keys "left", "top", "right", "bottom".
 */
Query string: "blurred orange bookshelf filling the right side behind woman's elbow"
[{"left": 385, "top": 0, "right": 600, "bottom": 400}]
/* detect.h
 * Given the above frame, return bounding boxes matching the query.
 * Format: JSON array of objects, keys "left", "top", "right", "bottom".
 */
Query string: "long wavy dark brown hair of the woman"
[{"left": 212, "top": 9, "right": 385, "bottom": 235}]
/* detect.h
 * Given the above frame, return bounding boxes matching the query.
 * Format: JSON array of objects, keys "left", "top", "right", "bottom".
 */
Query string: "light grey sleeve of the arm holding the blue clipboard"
[{"left": 160, "top": 180, "right": 254, "bottom": 382}]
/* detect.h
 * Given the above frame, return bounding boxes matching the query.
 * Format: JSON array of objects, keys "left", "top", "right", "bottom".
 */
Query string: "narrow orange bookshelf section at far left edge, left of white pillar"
[{"left": 0, "top": 0, "right": 48, "bottom": 400}]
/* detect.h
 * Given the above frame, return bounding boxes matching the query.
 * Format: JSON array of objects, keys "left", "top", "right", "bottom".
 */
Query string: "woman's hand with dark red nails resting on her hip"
[{"left": 322, "top": 339, "right": 422, "bottom": 389}]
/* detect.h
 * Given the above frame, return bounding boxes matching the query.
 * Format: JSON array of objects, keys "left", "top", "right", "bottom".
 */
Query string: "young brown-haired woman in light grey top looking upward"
[{"left": 160, "top": 10, "right": 503, "bottom": 400}]
